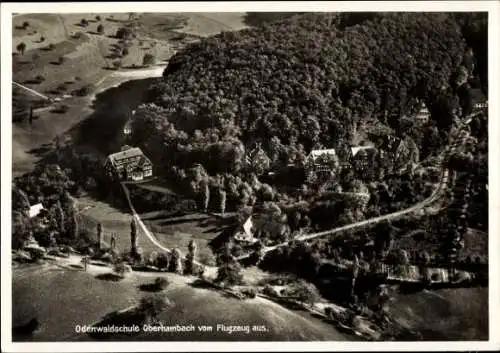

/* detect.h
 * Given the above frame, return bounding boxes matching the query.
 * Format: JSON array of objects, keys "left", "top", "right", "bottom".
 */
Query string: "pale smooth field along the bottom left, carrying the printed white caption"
[{"left": 13, "top": 267, "right": 346, "bottom": 341}]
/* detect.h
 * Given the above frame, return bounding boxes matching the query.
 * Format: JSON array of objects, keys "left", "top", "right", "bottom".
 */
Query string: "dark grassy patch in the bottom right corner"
[{"left": 390, "top": 288, "right": 488, "bottom": 340}]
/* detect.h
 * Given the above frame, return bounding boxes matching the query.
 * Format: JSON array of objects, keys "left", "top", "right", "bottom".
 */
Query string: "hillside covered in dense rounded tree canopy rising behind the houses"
[{"left": 127, "top": 13, "right": 466, "bottom": 210}]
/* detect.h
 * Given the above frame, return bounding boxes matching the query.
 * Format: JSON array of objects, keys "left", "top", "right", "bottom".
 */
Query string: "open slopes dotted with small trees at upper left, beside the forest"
[{"left": 12, "top": 13, "right": 250, "bottom": 175}]
